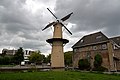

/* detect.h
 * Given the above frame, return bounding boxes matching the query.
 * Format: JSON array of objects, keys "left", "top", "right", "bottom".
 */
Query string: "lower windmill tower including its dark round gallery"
[{"left": 46, "top": 38, "right": 69, "bottom": 71}]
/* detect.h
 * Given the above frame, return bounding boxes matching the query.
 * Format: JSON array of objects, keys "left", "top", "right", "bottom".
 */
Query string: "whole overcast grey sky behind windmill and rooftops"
[{"left": 0, "top": 0, "right": 120, "bottom": 55}]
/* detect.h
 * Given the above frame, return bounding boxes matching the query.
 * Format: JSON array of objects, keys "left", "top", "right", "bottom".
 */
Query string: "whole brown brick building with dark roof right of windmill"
[{"left": 72, "top": 32, "right": 120, "bottom": 71}]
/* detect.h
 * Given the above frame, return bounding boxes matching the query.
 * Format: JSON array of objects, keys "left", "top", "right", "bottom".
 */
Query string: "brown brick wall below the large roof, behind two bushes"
[{"left": 73, "top": 44, "right": 110, "bottom": 69}]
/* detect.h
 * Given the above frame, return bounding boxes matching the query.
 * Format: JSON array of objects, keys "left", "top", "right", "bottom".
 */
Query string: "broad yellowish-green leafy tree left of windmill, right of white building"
[{"left": 29, "top": 51, "right": 45, "bottom": 63}]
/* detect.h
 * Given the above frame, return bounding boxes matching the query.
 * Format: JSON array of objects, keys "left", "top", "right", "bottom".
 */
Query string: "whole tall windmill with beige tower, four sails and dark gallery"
[{"left": 42, "top": 8, "right": 73, "bottom": 68}]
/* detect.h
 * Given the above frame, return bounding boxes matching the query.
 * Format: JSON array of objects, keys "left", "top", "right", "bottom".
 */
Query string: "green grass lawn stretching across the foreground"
[{"left": 0, "top": 71, "right": 120, "bottom": 80}]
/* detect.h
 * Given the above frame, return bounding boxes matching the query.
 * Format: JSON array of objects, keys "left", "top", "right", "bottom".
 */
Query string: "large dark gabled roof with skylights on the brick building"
[{"left": 72, "top": 31, "right": 109, "bottom": 48}]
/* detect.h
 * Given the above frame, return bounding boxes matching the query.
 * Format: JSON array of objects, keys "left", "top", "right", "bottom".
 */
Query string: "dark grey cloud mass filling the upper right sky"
[{"left": 56, "top": 0, "right": 120, "bottom": 35}]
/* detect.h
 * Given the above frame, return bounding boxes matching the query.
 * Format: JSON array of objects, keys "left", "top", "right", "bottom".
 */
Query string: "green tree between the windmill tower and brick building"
[{"left": 64, "top": 51, "right": 73, "bottom": 66}]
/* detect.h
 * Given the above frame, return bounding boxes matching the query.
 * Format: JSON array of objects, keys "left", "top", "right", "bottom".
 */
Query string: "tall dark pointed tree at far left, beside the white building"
[{"left": 14, "top": 47, "right": 24, "bottom": 64}]
